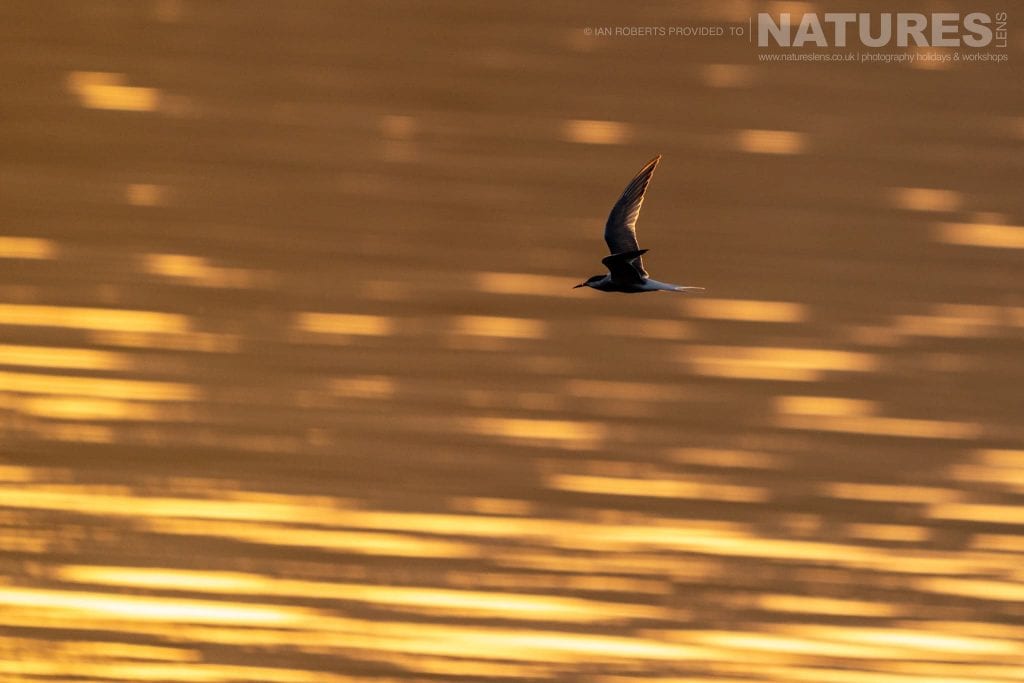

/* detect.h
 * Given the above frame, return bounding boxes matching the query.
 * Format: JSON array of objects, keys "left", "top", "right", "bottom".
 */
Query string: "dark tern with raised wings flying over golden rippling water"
[{"left": 572, "top": 155, "right": 705, "bottom": 294}]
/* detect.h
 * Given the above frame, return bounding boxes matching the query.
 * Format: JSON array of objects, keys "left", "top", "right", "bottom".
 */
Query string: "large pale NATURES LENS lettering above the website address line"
[{"left": 757, "top": 12, "right": 1008, "bottom": 48}]
